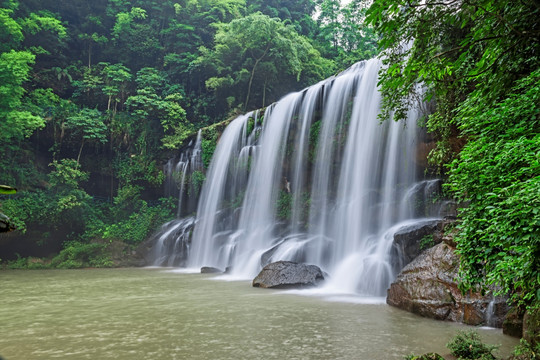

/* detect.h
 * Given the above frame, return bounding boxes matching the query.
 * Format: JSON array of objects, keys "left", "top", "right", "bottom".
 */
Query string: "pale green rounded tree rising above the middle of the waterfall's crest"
[{"left": 198, "top": 13, "right": 333, "bottom": 111}]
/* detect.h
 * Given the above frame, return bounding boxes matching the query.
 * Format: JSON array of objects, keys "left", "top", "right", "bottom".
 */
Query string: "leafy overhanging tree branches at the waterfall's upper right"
[{"left": 368, "top": 0, "right": 540, "bottom": 162}]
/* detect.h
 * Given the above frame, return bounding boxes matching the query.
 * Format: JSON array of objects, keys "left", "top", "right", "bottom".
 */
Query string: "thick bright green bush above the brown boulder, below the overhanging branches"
[{"left": 449, "top": 70, "right": 540, "bottom": 305}]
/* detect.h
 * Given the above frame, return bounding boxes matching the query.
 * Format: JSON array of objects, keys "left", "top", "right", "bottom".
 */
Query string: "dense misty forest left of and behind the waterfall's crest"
[{"left": 0, "top": 0, "right": 376, "bottom": 267}]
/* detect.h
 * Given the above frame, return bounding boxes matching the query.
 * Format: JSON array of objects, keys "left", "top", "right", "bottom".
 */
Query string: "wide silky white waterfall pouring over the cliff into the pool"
[{"left": 153, "top": 59, "right": 440, "bottom": 296}]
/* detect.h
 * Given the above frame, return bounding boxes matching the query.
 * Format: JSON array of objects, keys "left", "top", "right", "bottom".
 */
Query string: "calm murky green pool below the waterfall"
[{"left": 0, "top": 269, "right": 517, "bottom": 360}]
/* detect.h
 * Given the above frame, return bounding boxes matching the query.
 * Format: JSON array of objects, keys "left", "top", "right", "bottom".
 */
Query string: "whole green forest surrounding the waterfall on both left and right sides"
[{"left": 0, "top": 0, "right": 540, "bottom": 326}]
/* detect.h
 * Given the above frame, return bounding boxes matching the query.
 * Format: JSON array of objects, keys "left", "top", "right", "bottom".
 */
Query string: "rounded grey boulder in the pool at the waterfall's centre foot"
[{"left": 253, "top": 261, "right": 324, "bottom": 288}]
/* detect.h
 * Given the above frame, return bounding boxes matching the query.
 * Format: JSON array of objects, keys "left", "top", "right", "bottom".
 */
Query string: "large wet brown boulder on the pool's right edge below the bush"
[{"left": 386, "top": 243, "right": 507, "bottom": 326}]
